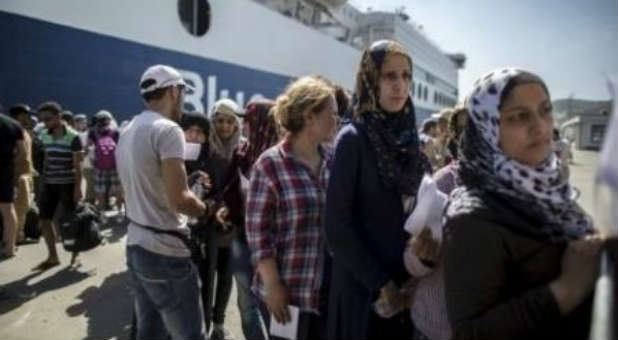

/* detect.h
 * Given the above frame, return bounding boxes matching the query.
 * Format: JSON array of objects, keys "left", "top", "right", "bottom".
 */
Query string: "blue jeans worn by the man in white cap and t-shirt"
[{"left": 127, "top": 246, "right": 206, "bottom": 340}]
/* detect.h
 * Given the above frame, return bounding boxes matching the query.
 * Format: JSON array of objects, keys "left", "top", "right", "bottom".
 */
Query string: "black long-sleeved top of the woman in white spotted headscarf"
[{"left": 444, "top": 191, "right": 592, "bottom": 339}]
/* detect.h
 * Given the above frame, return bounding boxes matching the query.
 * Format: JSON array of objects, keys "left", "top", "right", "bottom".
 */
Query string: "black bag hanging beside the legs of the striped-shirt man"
[{"left": 60, "top": 204, "right": 103, "bottom": 252}]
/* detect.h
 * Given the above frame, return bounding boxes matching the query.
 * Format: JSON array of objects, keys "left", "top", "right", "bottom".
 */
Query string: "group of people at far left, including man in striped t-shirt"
[{"left": 3, "top": 101, "right": 122, "bottom": 270}]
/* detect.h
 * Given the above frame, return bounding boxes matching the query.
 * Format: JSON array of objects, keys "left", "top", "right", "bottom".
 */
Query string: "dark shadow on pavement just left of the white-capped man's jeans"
[{"left": 66, "top": 272, "right": 133, "bottom": 339}]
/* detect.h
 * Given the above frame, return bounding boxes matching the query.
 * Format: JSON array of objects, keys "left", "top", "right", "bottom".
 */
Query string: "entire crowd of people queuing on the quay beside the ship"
[{"left": 0, "top": 40, "right": 605, "bottom": 339}]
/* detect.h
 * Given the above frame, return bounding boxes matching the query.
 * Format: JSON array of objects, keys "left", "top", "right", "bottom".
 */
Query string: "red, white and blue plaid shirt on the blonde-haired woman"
[{"left": 245, "top": 139, "right": 330, "bottom": 313}]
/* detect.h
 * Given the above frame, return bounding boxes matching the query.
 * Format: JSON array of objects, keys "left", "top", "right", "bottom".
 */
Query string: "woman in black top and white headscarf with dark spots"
[{"left": 445, "top": 68, "right": 602, "bottom": 339}]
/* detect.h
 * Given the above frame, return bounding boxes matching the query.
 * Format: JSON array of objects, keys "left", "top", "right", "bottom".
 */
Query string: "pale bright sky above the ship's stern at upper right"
[{"left": 349, "top": 0, "right": 618, "bottom": 100}]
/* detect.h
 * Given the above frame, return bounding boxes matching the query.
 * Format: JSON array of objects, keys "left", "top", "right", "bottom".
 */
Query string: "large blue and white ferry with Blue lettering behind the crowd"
[{"left": 0, "top": 0, "right": 465, "bottom": 122}]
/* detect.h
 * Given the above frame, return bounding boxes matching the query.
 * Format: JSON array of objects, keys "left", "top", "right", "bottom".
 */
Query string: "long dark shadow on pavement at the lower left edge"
[{"left": 0, "top": 267, "right": 93, "bottom": 315}]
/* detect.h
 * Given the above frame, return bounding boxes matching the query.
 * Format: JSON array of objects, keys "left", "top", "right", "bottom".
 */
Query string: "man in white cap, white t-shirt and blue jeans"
[{"left": 116, "top": 65, "right": 206, "bottom": 340}]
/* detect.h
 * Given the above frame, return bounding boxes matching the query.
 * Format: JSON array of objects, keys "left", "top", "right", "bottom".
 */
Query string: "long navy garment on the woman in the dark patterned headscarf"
[{"left": 325, "top": 123, "right": 409, "bottom": 339}]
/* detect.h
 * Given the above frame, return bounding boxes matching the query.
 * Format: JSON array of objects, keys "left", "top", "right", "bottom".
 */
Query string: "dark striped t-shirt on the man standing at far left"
[{"left": 40, "top": 125, "right": 82, "bottom": 184}]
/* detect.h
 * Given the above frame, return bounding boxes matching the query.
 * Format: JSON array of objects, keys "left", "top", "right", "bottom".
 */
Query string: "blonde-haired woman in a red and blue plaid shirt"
[{"left": 246, "top": 77, "right": 337, "bottom": 339}]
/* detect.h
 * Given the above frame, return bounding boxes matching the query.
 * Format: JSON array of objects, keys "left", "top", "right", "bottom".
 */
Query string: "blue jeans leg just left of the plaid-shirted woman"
[{"left": 231, "top": 236, "right": 268, "bottom": 340}]
